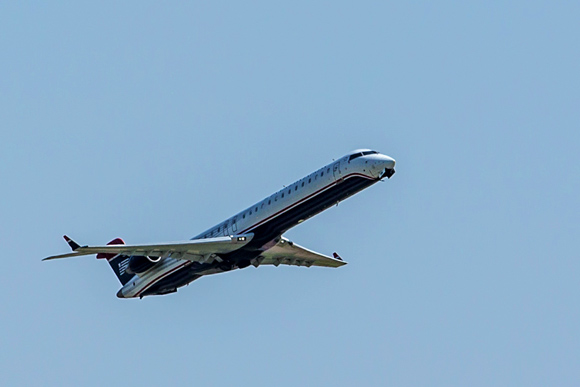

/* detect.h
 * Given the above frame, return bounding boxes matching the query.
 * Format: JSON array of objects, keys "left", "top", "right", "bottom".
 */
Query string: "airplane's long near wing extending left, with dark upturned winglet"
[{"left": 43, "top": 233, "right": 254, "bottom": 261}]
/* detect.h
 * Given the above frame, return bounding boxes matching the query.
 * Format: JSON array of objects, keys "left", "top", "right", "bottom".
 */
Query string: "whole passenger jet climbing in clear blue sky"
[{"left": 43, "top": 149, "right": 395, "bottom": 299}]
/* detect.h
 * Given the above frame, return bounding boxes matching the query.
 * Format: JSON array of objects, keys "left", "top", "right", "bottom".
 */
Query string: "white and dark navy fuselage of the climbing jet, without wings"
[{"left": 120, "top": 150, "right": 395, "bottom": 298}]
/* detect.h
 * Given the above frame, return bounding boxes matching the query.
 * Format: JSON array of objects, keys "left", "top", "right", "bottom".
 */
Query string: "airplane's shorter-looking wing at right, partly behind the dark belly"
[{"left": 258, "top": 238, "right": 346, "bottom": 267}]
